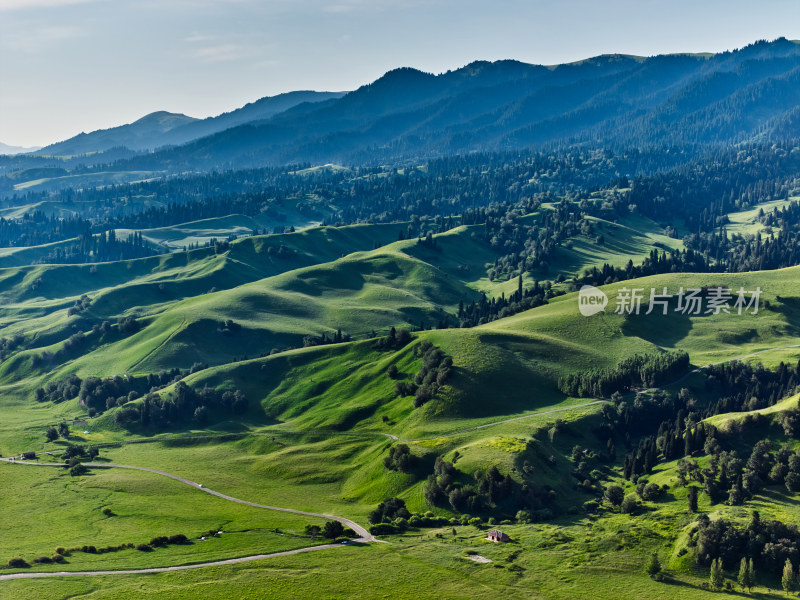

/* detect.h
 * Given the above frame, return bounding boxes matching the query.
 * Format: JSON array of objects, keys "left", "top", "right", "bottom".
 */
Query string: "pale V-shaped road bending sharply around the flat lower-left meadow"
[{"left": 0, "top": 457, "right": 376, "bottom": 581}]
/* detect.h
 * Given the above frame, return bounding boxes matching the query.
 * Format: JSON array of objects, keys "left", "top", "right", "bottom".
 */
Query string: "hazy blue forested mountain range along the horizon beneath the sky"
[{"left": 31, "top": 38, "right": 800, "bottom": 170}]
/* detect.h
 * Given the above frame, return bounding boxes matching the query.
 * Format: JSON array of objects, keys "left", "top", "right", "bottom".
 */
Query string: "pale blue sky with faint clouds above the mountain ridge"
[{"left": 0, "top": 0, "right": 800, "bottom": 146}]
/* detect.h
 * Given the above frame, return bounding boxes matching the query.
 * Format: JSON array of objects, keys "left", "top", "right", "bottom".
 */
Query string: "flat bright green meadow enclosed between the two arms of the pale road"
[{"left": 0, "top": 463, "right": 323, "bottom": 571}]
